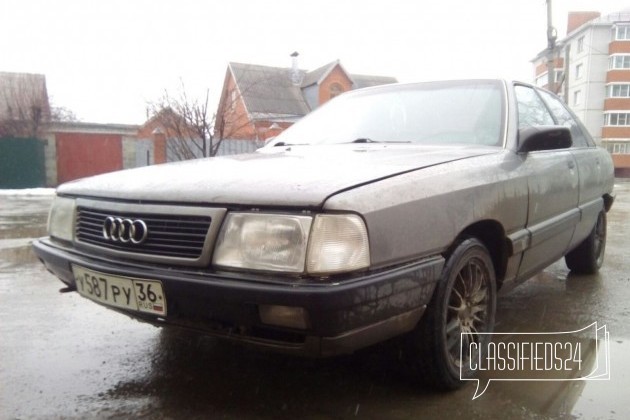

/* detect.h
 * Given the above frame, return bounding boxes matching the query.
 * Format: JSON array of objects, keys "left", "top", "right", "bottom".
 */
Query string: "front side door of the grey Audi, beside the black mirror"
[{"left": 514, "top": 85, "right": 579, "bottom": 278}]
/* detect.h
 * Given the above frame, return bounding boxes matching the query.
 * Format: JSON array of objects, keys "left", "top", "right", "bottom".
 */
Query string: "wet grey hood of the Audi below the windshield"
[{"left": 58, "top": 144, "right": 498, "bottom": 207}]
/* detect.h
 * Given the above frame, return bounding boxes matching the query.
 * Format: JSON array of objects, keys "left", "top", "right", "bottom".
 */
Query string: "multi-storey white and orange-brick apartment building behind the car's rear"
[{"left": 532, "top": 9, "right": 630, "bottom": 177}]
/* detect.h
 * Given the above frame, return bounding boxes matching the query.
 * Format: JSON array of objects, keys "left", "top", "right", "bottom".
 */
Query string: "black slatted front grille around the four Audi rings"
[{"left": 76, "top": 207, "right": 212, "bottom": 259}]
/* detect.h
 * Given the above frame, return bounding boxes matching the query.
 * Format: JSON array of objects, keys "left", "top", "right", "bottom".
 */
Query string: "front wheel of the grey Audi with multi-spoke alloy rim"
[{"left": 405, "top": 239, "right": 496, "bottom": 390}]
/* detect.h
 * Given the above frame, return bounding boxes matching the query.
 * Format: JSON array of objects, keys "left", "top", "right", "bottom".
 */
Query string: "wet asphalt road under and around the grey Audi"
[{"left": 0, "top": 187, "right": 630, "bottom": 419}]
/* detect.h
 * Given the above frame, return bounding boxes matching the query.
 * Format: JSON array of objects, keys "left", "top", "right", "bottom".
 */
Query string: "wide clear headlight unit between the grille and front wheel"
[{"left": 213, "top": 213, "right": 370, "bottom": 275}]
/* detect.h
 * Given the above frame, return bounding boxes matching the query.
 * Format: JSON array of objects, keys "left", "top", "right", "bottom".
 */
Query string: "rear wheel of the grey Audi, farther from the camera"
[{"left": 564, "top": 210, "right": 606, "bottom": 274}]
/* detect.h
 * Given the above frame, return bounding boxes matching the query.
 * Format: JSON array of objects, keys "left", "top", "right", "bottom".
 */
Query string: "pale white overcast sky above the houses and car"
[{"left": 0, "top": 0, "right": 628, "bottom": 124}]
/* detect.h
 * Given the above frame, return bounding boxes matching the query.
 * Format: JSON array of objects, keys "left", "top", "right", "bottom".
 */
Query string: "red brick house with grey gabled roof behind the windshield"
[{"left": 215, "top": 53, "right": 397, "bottom": 154}]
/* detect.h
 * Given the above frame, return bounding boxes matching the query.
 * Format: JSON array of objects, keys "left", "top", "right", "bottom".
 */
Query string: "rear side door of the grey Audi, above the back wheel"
[{"left": 539, "top": 91, "right": 607, "bottom": 248}]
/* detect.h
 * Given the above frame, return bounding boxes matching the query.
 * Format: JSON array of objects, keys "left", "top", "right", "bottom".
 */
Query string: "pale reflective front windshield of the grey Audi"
[{"left": 270, "top": 81, "right": 504, "bottom": 146}]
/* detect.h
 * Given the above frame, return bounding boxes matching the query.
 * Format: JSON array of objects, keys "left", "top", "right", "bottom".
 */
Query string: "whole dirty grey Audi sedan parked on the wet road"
[{"left": 34, "top": 80, "right": 613, "bottom": 388}]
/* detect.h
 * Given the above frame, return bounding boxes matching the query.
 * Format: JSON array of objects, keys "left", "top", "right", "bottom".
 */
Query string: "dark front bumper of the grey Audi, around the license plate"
[{"left": 33, "top": 238, "right": 444, "bottom": 357}]
